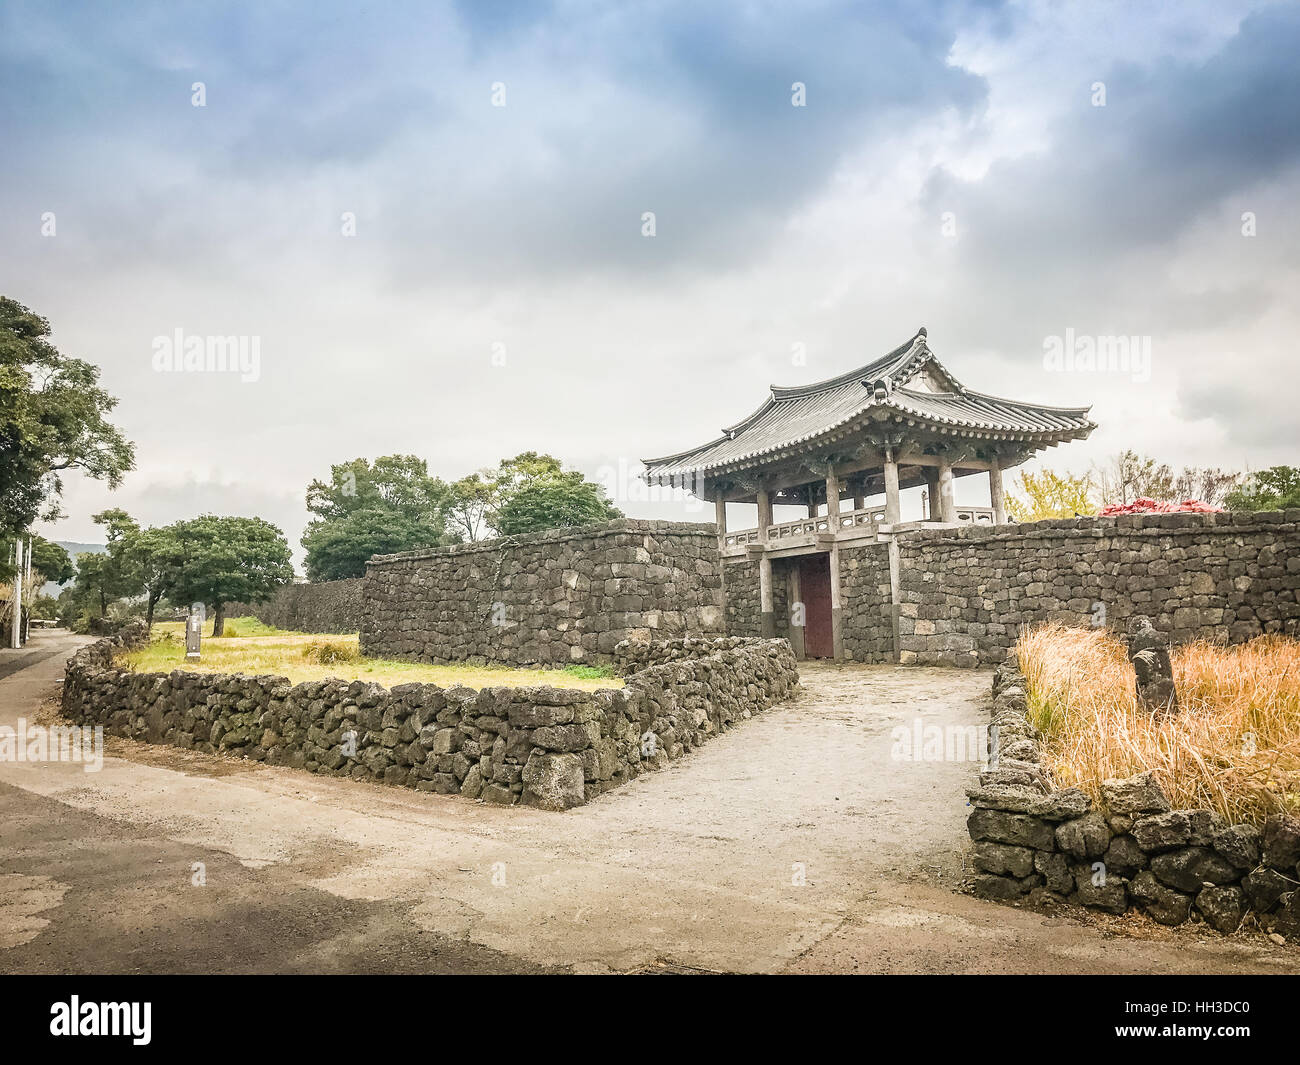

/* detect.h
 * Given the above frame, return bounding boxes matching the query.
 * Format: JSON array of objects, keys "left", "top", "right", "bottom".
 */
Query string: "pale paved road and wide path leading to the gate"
[{"left": 0, "top": 633, "right": 1300, "bottom": 973}]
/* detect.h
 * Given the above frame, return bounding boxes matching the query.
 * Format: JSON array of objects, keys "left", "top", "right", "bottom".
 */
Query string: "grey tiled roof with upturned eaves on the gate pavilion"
[{"left": 642, "top": 329, "right": 1096, "bottom": 482}]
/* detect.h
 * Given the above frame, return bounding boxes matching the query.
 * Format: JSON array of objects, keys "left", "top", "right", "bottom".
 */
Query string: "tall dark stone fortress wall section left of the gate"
[{"left": 360, "top": 519, "right": 725, "bottom": 666}]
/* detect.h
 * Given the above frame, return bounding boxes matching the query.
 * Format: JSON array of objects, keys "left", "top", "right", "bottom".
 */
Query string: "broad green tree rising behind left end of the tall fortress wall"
[{"left": 302, "top": 455, "right": 454, "bottom": 580}]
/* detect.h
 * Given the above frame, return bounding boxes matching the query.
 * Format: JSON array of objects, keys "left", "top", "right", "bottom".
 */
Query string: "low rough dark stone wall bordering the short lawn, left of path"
[{"left": 62, "top": 625, "right": 798, "bottom": 810}]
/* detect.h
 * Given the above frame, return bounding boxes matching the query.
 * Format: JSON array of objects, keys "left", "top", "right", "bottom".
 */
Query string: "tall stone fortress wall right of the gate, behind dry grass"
[{"left": 898, "top": 510, "right": 1300, "bottom": 666}]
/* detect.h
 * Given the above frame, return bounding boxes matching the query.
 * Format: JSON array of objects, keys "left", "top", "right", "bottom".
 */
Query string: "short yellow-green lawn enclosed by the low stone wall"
[{"left": 118, "top": 618, "right": 623, "bottom": 690}]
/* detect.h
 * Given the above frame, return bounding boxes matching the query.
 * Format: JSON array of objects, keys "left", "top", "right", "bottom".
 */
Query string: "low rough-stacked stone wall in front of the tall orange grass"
[{"left": 967, "top": 651, "right": 1300, "bottom": 936}]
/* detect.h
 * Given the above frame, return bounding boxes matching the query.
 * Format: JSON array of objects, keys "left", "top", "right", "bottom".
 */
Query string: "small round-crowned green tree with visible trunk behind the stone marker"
[{"left": 169, "top": 514, "right": 294, "bottom": 636}]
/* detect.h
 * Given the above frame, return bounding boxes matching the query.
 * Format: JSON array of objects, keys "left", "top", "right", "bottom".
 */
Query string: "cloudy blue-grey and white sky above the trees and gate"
[{"left": 0, "top": 0, "right": 1300, "bottom": 561}]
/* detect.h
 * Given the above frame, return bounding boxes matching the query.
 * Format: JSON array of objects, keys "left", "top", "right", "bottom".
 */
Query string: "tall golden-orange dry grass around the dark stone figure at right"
[{"left": 1017, "top": 624, "right": 1300, "bottom": 824}]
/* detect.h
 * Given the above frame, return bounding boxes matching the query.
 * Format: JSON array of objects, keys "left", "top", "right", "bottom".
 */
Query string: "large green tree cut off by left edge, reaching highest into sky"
[{"left": 0, "top": 296, "right": 135, "bottom": 548}]
